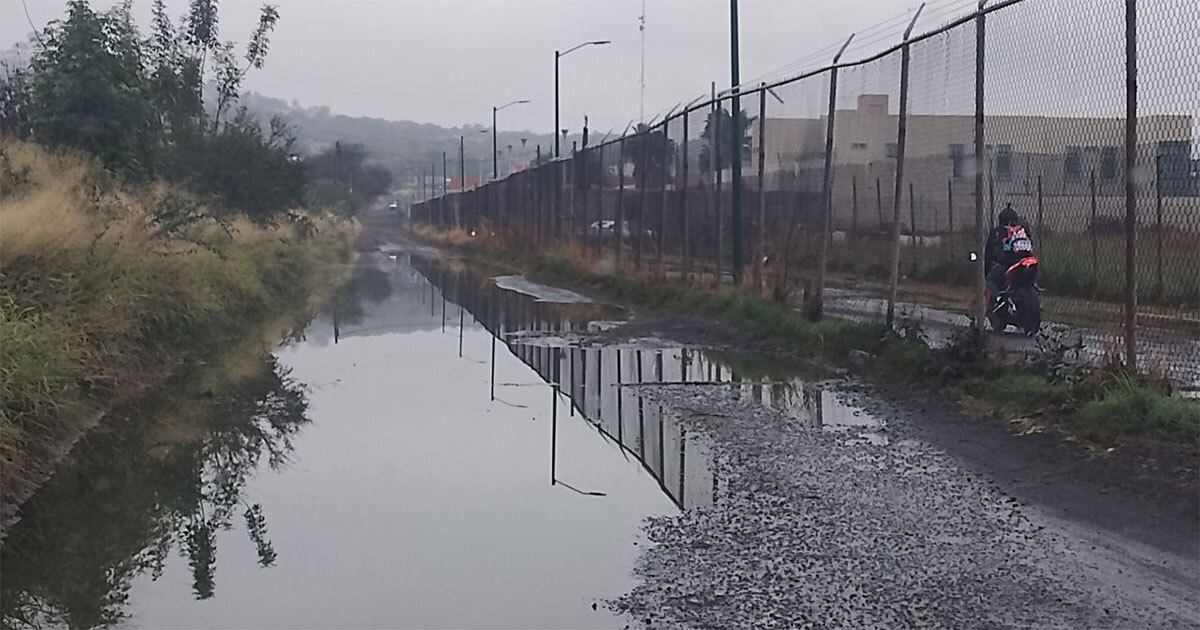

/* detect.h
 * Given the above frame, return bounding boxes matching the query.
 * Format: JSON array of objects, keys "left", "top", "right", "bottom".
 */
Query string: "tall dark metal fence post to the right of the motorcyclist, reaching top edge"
[{"left": 1124, "top": 0, "right": 1138, "bottom": 373}]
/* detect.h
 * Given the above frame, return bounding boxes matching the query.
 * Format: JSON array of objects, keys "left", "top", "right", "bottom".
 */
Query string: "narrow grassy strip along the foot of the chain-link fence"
[{"left": 416, "top": 227, "right": 1200, "bottom": 449}]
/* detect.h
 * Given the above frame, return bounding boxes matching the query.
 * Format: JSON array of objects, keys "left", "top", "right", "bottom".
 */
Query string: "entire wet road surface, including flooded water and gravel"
[{"left": 0, "top": 219, "right": 1200, "bottom": 628}]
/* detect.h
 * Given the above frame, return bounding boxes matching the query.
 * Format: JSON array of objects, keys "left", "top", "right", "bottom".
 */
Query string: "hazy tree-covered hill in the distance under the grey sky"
[{"left": 242, "top": 92, "right": 577, "bottom": 180}]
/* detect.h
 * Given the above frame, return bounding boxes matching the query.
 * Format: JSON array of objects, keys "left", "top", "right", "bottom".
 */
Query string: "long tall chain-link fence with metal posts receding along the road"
[{"left": 412, "top": 0, "right": 1200, "bottom": 388}]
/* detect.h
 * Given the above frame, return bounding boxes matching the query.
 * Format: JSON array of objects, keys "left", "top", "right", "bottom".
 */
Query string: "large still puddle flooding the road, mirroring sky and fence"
[{"left": 0, "top": 254, "right": 884, "bottom": 628}]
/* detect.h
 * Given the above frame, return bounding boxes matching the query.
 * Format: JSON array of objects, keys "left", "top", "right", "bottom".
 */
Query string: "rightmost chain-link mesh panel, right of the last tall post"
[{"left": 1134, "top": 0, "right": 1200, "bottom": 388}]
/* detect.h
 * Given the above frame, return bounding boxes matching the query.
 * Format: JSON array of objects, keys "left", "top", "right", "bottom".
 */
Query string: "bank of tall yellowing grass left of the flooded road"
[{"left": 0, "top": 143, "right": 355, "bottom": 496}]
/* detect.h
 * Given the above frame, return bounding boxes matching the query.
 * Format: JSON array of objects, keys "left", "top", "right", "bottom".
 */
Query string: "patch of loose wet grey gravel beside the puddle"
[{"left": 608, "top": 385, "right": 1198, "bottom": 629}]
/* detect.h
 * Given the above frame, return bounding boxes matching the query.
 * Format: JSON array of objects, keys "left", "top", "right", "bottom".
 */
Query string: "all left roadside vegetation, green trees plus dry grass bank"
[{"left": 0, "top": 0, "right": 374, "bottom": 516}]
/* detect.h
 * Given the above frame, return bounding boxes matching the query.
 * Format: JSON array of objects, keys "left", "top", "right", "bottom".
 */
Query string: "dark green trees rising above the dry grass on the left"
[{"left": 0, "top": 0, "right": 305, "bottom": 222}]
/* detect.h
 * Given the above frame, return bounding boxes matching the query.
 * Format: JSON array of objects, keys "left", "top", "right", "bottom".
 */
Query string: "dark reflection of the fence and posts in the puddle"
[{"left": 412, "top": 258, "right": 887, "bottom": 508}]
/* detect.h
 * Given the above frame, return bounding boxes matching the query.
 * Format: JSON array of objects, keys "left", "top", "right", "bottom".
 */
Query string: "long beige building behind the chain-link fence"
[{"left": 746, "top": 94, "right": 1200, "bottom": 233}]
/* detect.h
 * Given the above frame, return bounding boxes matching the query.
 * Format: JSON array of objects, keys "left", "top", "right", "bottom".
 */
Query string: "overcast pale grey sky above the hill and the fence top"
[{"left": 0, "top": 0, "right": 974, "bottom": 132}]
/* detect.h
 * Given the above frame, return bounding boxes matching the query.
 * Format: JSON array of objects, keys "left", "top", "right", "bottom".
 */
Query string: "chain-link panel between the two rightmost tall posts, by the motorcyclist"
[{"left": 984, "top": 0, "right": 1132, "bottom": 369}]
